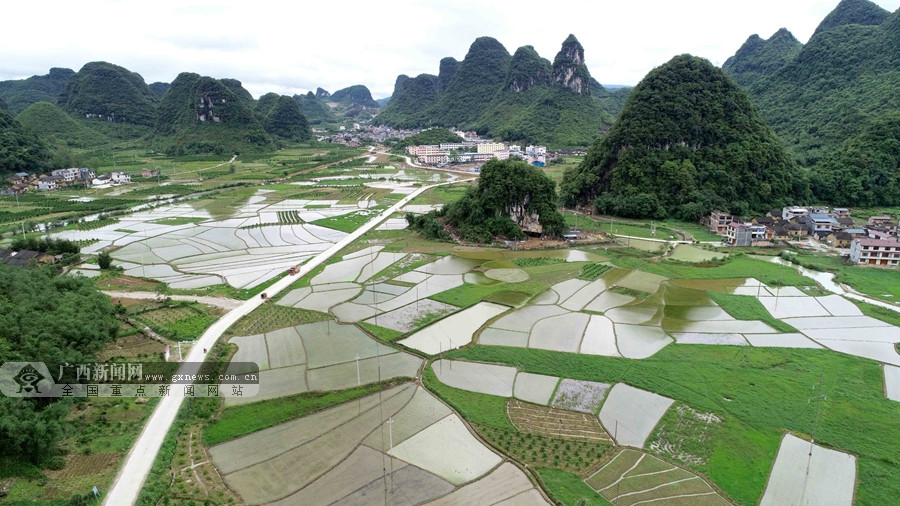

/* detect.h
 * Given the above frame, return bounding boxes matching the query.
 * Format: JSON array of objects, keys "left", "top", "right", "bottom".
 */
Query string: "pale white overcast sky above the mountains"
[{"left": 0, "top": 0, "right": 900, "bottom": 98}]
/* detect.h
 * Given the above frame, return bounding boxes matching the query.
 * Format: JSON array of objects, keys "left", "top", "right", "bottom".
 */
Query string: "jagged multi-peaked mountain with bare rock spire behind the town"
[{"left": 375, "top": 35, "right": 627, "bottom": 147}]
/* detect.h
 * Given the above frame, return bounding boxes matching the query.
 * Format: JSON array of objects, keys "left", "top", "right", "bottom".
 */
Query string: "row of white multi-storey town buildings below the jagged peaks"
[{"left": 406, "top": 140, "right": 547, "bottom": 167}]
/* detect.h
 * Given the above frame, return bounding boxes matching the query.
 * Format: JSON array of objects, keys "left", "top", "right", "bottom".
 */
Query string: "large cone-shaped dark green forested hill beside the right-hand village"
[{"left": 561, "top": 55, "right": 808, "bottom": 220}]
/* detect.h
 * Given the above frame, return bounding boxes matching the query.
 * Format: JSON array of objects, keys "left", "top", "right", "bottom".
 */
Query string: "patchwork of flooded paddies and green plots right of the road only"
[{"left": 185, "top": 231, "right": 900, "bottom": 504}]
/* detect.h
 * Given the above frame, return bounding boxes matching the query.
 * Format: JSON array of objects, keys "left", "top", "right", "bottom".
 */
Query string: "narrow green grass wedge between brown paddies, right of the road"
[{"left": 203, "top": 378, "right": 409, "bottom": 446}]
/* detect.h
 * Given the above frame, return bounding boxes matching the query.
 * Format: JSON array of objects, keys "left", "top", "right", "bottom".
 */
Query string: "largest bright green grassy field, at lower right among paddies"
[{"left": 446, "top": 346, "right": 900, "bottom": 504}]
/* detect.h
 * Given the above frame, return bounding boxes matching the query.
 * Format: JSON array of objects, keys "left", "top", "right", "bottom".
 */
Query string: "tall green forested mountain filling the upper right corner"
[{"left": 724, "top": 0, "right": 900, "bottom": 167}]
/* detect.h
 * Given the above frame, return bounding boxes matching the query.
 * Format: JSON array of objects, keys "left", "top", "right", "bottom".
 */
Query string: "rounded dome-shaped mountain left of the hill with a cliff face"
[{"left": 59, "top": 62, "right": 157, "bottom": 126}]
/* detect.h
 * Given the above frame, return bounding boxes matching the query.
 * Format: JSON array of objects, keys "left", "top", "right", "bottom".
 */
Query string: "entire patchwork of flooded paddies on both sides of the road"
[{"left": 40, "top": 152, "right": 900, "bottom": 506}]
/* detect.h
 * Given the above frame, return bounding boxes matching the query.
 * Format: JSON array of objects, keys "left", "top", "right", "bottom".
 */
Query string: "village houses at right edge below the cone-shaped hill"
[{"left": 701, "top": 206, "right": 900, "bottom": 267}]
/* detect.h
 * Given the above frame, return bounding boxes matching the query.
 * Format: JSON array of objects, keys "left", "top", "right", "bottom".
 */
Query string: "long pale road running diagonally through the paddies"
[{"left": 103, "top": 181, "right": 472, "bottom": 506}]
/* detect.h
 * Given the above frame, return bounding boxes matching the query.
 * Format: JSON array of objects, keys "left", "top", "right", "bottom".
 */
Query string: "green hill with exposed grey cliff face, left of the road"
[{"left": 155, "top": 72, "right": 271, "bottom": 154}]
